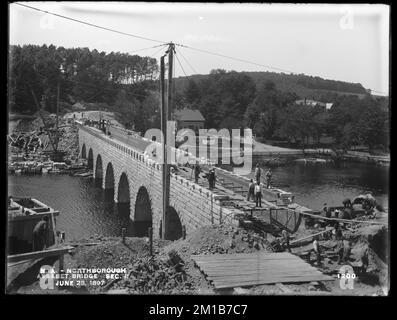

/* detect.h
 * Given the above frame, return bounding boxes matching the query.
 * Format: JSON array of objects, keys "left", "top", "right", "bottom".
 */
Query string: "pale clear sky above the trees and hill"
[{"left": 9, "top": 1, "right": 390, "bottom": 95}]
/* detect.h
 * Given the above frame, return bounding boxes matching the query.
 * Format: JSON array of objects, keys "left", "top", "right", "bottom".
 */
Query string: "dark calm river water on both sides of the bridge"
[{"left": 8, "top": 163, "right": 389, "bottom": 240}]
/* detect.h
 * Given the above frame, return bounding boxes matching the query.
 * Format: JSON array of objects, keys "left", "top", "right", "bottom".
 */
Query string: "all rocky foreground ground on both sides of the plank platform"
[{"left": 6, "top": 220, "right": 388, "bottom": 295}]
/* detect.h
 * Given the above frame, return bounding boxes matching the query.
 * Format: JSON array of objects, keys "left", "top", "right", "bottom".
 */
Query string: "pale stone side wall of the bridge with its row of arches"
[{"left": 79, "top": 126, "right": 234, "bottom": 240}]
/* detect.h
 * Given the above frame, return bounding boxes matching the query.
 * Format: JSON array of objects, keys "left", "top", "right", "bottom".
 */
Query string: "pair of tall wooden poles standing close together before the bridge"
[{"left": 160, "top": 42, "right": 175, "bottom": 239}]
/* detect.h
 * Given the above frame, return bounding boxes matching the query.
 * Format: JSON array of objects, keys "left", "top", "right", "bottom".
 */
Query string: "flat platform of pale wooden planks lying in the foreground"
[{"left": 192, "top": 252, "right": 334, "bottom": 289}]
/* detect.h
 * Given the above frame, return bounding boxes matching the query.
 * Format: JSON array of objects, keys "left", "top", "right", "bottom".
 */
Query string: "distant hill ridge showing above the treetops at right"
[{"left": 175, "top": 72, "right": 368, "bottom": 102}]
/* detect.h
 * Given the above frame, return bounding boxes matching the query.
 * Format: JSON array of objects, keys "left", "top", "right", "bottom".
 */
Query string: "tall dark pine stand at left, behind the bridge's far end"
[{"left": 9, "top": 45, "right": 158, "bottom": 112}]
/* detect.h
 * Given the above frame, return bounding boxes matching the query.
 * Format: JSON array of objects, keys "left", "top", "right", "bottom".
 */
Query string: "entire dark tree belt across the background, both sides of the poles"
[{"left": 8, "top": 45, "right": 389, "bottom": 152}]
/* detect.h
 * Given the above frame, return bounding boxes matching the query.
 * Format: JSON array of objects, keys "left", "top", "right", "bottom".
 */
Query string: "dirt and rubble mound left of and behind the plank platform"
[{"left": 10, "top": 225, "right": 271, "bottom": 294}]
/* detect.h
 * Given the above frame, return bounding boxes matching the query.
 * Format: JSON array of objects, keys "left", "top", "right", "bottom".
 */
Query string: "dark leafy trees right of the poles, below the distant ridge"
[{"left": 179, "top": 70, "right": 389, "bottom": 149}]
